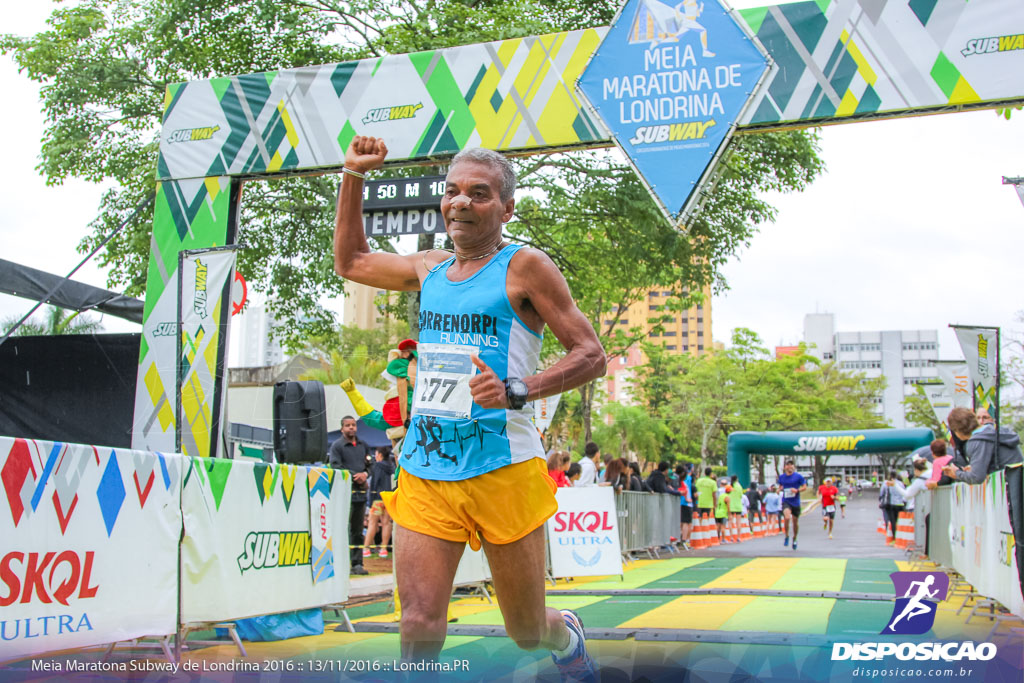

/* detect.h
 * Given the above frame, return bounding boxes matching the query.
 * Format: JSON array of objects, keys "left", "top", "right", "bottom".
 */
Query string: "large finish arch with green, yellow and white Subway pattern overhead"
[{"left": 132, "top": 0, "right": 1024, "bottom": 458}]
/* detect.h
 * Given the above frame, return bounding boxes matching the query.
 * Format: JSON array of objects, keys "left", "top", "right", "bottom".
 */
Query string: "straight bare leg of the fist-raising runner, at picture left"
[{"left": 394, "top": 523, "right": 466, "bottom": 660}]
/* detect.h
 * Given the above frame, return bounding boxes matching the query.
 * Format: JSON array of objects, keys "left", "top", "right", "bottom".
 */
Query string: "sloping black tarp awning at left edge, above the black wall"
[{"left": 0, "top": 258, "right": 143, "bottom": 324}]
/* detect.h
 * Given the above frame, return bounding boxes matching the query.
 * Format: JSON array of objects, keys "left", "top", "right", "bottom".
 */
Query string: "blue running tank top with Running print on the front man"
[{"left": 401, "top": 245, "right": 544, "bottom": 481}]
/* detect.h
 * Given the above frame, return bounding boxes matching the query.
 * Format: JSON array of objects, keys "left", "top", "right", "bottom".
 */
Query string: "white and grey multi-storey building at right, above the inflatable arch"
[{"left": 835, "top": 330, "right": 939, "bottom": 428}]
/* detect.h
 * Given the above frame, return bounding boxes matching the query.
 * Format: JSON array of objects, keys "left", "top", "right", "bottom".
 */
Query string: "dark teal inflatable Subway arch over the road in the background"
[{"left": 726, "top": 427, "right": 935, "bottom": 488}]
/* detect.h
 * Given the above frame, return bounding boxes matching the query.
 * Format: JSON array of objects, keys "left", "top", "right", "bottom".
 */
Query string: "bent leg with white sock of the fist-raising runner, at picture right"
[{"left": 477, "top": 526, "right": 569, "bottom": 650}]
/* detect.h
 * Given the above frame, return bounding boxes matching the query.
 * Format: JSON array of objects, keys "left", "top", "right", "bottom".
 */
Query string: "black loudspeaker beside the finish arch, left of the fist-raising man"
[{"left": 273, "top": 381, "right": 327, "bottom": 463}]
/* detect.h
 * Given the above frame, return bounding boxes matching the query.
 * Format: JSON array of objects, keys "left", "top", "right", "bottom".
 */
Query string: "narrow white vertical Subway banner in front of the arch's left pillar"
[{"left": 177, "top": 246, "right": 236, "bottom": 457}]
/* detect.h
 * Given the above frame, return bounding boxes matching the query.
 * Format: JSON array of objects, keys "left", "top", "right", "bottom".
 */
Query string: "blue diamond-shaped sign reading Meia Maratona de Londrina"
[{"left": 577, "top": 0, "right": 769, "bottom": 222}]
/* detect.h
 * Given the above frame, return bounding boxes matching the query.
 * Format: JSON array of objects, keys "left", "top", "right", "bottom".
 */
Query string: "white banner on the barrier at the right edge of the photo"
[{"left": 949, "top": 470, "right": 1024, "bottom": 617}]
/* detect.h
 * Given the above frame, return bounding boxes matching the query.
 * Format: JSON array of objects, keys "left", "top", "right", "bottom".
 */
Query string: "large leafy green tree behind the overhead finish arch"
[{"left": 0, "top": 0, "right": 822, "bottom": 438}]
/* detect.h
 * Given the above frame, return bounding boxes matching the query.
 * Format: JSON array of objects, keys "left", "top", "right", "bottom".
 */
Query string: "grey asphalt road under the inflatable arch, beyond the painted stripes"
[{"left": 682, "top": 488, "right": 906, "bottom": 560}]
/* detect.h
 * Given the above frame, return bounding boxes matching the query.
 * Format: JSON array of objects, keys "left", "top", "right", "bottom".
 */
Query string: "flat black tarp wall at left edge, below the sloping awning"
[{"left": 0, "top": 334, "right": 142, "bottom": 447}]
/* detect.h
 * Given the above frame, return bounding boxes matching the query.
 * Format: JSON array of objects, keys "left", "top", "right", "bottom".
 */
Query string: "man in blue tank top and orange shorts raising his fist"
[{"left": 334, "top": 136, "right": 605, "bottom": 681}]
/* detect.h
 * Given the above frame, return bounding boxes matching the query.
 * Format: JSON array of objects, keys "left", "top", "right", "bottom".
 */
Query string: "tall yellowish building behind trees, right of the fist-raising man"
[{"left": 602, "top": 287, "right": 712, "bottom": 404}]
